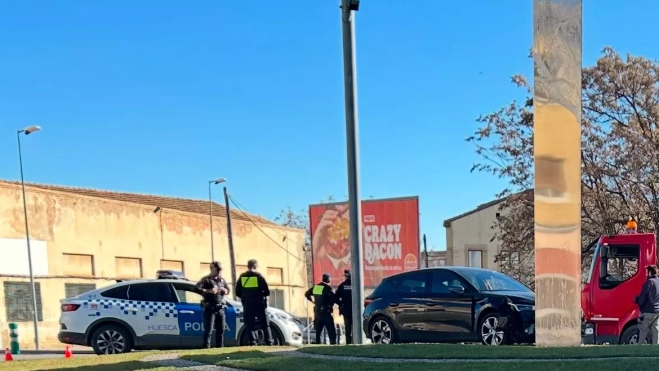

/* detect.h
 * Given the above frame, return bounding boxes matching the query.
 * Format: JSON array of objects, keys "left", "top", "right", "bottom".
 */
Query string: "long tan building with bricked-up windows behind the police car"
[{"left": 0, "top": 181, "right": 307, "bottom": 349}]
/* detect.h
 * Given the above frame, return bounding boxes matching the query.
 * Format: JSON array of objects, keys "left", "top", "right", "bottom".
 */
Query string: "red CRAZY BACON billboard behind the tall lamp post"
[{"left": 309, "top": 197, "right": 420, "bottom": 287}]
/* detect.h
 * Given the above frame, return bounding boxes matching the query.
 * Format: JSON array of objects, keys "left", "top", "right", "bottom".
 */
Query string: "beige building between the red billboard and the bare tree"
[{"left": 444, "top": 200, "right": 503, "bottom": 270}]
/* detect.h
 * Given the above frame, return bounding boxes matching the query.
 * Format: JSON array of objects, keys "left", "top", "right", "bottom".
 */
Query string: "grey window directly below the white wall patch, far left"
[{"left": 5, "top": 282, "right": 43, "bottom": 322}]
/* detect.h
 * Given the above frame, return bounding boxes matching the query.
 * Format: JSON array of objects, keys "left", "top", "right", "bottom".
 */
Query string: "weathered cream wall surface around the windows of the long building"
[{"left": 0, "top": 183, "right": 307, "bottom": 349}]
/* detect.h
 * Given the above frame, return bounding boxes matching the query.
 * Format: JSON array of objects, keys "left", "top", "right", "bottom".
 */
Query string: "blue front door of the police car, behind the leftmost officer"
[{"left": 172, "top": 282, "right": 208, "bottom": 348}]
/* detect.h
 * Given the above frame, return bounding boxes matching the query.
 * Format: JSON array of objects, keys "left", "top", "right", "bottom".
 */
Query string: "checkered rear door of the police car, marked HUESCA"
[{"left": 121, "top": 282, "right": 179, "bottom": 349}]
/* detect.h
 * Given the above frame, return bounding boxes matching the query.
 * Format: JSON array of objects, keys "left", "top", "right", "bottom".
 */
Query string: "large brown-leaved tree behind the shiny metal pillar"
[{"left": 467, "top": 48, "right": 659, "bottom": 284}]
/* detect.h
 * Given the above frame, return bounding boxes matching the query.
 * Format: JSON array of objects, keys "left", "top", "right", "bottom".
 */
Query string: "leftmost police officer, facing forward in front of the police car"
[{"left": 197, "top": 262, "right": 229, "bottom": 348}]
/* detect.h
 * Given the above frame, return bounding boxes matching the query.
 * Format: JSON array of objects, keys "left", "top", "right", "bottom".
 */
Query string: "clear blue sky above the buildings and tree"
[{"left": 0, "top": 0, "right": 659, "bottom": 248}]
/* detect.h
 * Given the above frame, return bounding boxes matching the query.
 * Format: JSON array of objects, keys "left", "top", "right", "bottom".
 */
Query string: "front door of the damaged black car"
[{"left": 426, "top": 269, "right": 474, "bottom": 341}]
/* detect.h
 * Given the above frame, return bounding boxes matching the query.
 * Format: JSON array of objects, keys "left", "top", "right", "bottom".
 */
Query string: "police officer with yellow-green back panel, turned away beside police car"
[{"left": 236, "top": 259, "right": 274, "bottom": 345}]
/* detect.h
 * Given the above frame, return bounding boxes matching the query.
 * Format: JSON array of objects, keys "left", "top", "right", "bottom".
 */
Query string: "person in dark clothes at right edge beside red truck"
[{"left": 636, "top": 265, "right": 659, "bottom": 345}]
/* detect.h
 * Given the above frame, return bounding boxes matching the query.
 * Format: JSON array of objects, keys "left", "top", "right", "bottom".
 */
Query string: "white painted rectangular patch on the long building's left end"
[{"left": 0, "top": 238, "right": 48, "bottom": 276}]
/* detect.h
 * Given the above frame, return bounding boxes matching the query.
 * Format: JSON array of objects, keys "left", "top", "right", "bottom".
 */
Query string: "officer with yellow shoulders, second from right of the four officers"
[{"left": 304, "top": 273, "right": 336, "bottom": 345}]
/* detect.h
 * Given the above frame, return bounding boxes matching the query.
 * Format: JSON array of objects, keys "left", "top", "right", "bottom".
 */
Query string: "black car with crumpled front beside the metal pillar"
[{"left": 363, "top": 267, "right": 535, "bottom": 345}]
